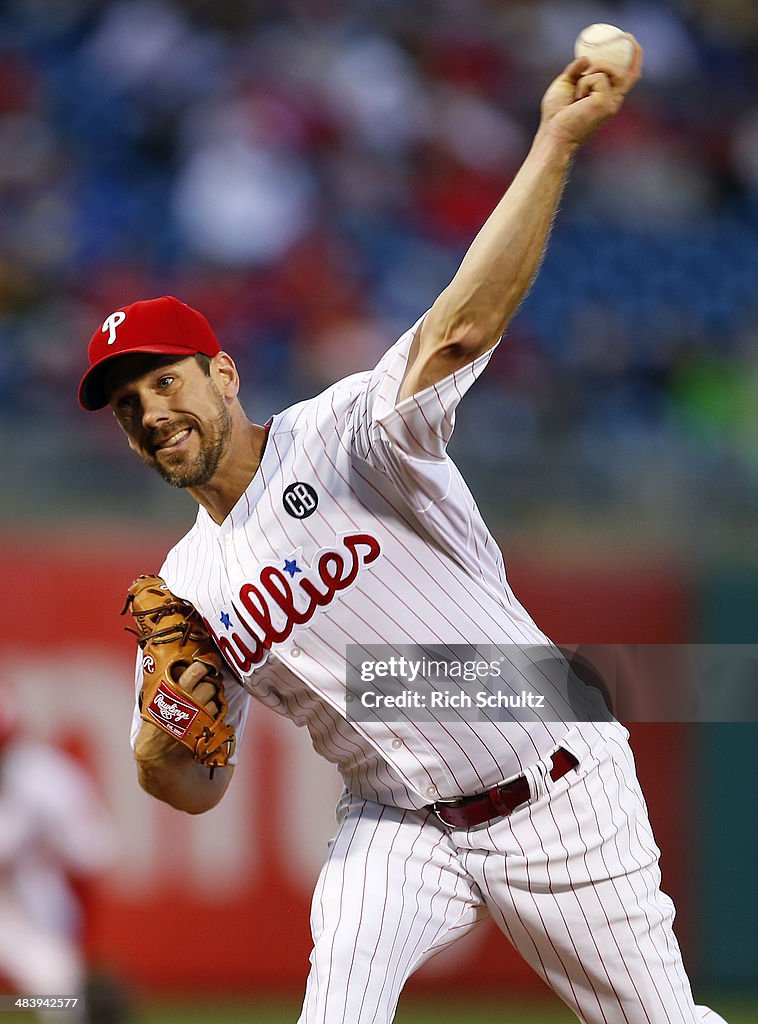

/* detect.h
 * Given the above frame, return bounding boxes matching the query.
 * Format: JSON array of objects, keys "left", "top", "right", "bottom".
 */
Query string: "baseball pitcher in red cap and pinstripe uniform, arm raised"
[{"left": 80, "top": 44, "right": 722, "bottom": 1024}]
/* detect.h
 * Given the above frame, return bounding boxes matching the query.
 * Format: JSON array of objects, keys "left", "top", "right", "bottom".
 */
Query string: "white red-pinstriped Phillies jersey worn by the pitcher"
[{"left": 132, "top": 313, "right": 598, "bottom": 807}]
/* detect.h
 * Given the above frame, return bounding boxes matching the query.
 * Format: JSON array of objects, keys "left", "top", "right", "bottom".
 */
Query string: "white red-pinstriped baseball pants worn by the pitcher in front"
[{"left": 299, "top": 726, "right": 725, "bottom": 1024}]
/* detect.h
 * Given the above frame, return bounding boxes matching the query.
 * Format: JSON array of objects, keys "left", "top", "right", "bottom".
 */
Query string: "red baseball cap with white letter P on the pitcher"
[{"left": 79, "top": 295, "right": 221, "bottom": 410}]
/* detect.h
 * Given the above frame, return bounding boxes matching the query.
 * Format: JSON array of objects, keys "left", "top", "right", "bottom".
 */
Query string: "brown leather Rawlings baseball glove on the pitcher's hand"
[{"left": 122, "top": 575, "right": 236, "bottom": 768}]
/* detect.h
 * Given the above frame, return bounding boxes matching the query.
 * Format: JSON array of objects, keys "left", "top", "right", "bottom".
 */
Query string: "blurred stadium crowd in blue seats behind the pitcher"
[{"left": 0, "top": 0, "right": 758, "bottom": 543}]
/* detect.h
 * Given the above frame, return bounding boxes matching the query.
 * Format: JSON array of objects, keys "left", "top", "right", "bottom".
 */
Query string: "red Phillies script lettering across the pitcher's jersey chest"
[{"left": 205, "top": 534, "right": 381, "bottom": 673}]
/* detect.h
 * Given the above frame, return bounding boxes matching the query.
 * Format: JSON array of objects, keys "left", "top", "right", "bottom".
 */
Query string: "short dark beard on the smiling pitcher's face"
[{"left": 142, "top": 393, "right": 231, "bottom": 487}]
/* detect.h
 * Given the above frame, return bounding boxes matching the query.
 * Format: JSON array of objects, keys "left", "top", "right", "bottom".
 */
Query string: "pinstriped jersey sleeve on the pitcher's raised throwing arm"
[{"left": 351, "top": 314, "right": 497, "bottom": 512}]
